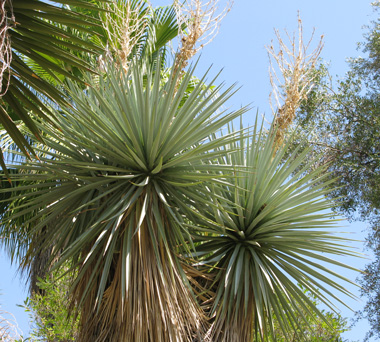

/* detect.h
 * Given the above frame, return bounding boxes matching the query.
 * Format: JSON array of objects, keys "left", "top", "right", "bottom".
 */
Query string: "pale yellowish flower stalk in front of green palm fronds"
[{"left": 100, "top": 0, "right": 147, "bottom": 71}]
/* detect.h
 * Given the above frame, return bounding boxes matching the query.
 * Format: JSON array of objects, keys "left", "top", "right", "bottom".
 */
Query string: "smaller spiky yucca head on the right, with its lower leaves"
[{"left": 191, "top": 121, "right": 356, "bottom": 341}]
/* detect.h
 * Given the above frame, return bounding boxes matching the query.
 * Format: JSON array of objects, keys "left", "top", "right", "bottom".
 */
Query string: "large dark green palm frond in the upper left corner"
[{"left": 0, "top": 0, "right": 104, "bottom": 170}]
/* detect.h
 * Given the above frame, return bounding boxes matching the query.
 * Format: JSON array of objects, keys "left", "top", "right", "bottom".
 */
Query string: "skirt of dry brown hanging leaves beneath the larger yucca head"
[{"left": 75, "top": 201, "right": 204, "bottom": 342}]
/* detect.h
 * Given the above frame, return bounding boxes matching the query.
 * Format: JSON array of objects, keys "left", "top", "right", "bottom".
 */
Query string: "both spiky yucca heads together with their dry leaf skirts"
[{"left": 1, "top": 62, "right": 360, "bottom": 341}]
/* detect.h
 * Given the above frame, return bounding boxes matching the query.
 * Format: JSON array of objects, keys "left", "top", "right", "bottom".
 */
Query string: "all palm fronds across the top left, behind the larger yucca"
[{"left": 0, "top": 0, "right": 185, "bottom": 172}]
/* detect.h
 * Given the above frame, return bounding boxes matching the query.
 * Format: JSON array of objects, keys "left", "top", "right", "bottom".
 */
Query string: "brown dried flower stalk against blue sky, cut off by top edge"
[{"left": 174, "top": 0, "right": 233, "bottom": 79}]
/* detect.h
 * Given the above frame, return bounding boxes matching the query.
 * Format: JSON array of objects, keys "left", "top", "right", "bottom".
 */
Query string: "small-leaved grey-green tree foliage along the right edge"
[{"left": 295, "top": 1, "right": 380, "bottom": 338}]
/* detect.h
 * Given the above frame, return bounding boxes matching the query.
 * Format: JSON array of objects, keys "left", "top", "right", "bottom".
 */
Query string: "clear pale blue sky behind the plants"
[{"left": 0, "top": 0, "right": 373, "bottom": 341}]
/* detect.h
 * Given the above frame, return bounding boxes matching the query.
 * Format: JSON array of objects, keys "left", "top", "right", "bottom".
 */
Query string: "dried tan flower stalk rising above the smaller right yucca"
[{"left": 267, "top": 15, "right": 324, "bottom": 146}]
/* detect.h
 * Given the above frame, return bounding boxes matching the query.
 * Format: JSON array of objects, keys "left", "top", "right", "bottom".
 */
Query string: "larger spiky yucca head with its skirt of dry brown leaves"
[{"left": 1, "top": 63, "right": 249, "bottom": 341}]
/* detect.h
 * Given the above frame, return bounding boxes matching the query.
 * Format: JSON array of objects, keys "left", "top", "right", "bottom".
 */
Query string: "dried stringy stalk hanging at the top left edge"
[{"left": 0, "top": 0, "right": 15, "bottom": 96}]
